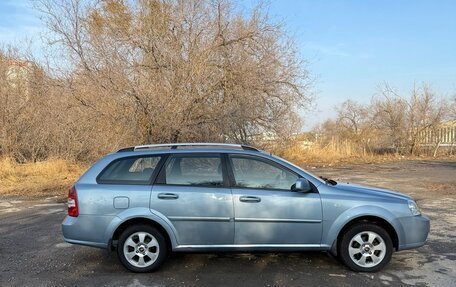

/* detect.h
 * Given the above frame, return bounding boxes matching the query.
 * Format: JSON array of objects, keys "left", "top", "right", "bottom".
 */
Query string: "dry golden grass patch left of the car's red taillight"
[{"left": 0, "top": 158, "right": 85, "bottom": 199}]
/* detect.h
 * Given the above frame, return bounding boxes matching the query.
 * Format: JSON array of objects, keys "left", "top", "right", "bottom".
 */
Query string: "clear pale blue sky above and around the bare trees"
[{"left": 0, "top": 0, "right": 456, "bottom": 129}]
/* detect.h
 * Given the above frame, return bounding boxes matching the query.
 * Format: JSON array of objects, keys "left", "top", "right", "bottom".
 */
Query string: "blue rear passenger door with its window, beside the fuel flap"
[{"left": 150, "top": 153, "right": 234, "bottom": 245}]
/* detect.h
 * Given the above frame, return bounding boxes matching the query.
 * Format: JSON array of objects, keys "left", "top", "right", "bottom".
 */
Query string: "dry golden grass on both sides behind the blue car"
[{"left": 0, "top": 143, "right": 454, "bottom": 199}]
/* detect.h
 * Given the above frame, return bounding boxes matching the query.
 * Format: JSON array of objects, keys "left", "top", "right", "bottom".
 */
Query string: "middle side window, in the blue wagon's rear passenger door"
[{"left": 164, "top": 154, "right": 223, "bottom": 187}]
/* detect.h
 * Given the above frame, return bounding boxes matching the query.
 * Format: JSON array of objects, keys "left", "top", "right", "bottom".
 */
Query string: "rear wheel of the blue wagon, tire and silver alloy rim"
[{"left": 117, "top": 225, "right": 168, "bottom": 273}]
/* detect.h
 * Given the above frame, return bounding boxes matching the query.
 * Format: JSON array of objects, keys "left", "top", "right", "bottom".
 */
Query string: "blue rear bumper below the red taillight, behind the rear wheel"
[{"left": 62, "top": 215, "right": 109, "bottom": 248}]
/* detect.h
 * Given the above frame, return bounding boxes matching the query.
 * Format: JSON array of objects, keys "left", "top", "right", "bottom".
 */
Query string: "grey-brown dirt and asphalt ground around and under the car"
[{"left": 0, "top": 161, "right": 456, "bottom": 286}]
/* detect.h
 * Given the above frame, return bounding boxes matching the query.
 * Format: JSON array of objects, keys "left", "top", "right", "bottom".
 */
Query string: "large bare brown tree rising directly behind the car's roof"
[{"left": 36, "top": 0, "right": 310, "bottom": 148}]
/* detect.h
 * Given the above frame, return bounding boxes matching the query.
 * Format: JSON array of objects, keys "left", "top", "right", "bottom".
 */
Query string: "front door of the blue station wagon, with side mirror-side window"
[{"left": 229, "top": 154, "right": 322, "bottom": 246}]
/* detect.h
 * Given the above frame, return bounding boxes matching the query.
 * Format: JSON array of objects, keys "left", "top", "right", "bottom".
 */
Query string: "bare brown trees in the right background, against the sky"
[{"left": 314, "top": 83, "right": 451, "bottom": 158}]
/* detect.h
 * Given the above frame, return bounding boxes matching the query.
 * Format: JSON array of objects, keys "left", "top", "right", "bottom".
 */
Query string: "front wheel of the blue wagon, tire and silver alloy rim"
[{"left": 338, "top": 223, "right": 393, "bottom": 272}]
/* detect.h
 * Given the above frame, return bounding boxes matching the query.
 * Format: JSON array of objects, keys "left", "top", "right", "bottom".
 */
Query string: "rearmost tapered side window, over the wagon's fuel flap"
[{"left": 97, "top": 156, "right": 161, "bottom": 184}]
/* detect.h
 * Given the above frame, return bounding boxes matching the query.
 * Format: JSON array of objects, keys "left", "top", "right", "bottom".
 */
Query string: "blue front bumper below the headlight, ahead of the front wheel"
[{"left": 398, "top": 215, "right": 430, "bottom": 250}]
